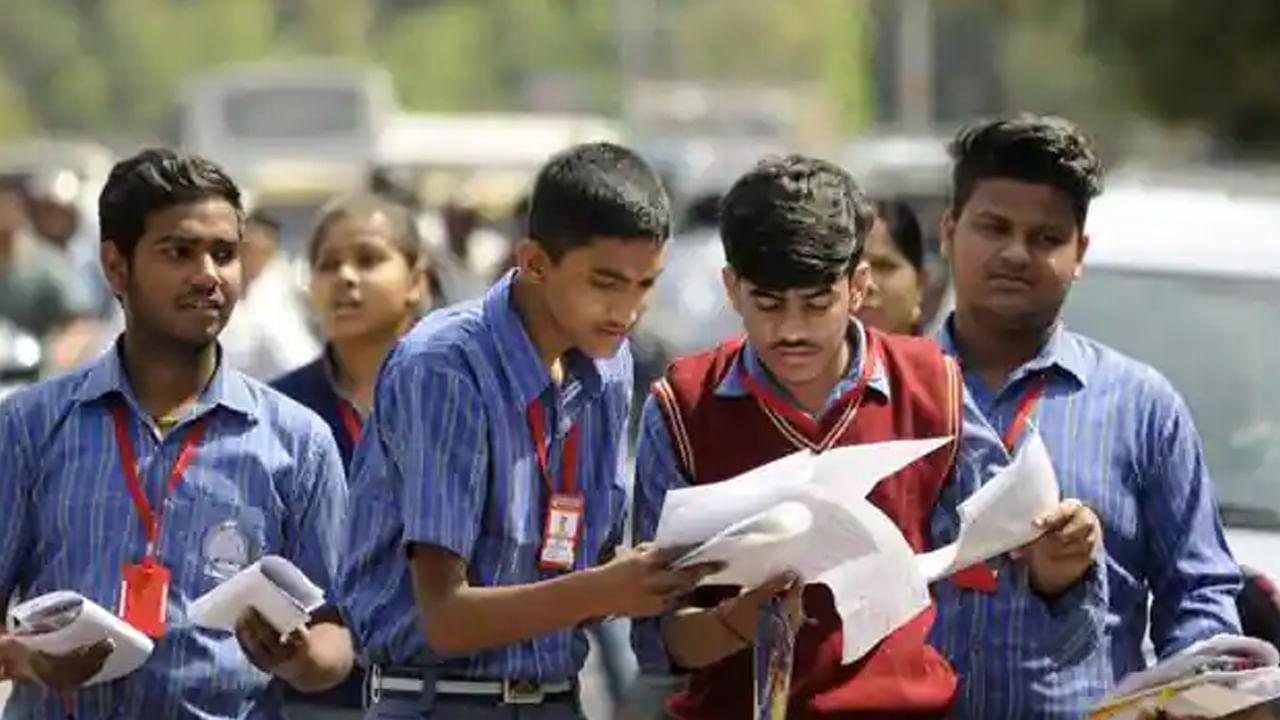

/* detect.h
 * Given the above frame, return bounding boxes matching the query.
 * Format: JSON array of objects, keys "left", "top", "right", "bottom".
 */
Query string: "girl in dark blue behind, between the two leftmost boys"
[{"left": 271, "top": 195, "right": 431, "bottom": 720}]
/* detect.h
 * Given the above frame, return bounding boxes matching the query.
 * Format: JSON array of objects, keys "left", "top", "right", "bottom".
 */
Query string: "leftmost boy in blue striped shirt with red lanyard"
[{"left": 0, "top": 150, "right": 352, "bottom": 720}]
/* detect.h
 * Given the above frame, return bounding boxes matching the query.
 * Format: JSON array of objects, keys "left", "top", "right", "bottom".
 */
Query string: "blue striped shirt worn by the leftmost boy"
[{"left": 0, "top": 340, "right": 346, "bottom": 720}]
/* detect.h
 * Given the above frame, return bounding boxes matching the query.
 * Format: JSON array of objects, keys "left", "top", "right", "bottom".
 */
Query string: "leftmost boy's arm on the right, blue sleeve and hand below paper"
[{"left": 274, "top": 420, "right": 355, "bottom": 692}]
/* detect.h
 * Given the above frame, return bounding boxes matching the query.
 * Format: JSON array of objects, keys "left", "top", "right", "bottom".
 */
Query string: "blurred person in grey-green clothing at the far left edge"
[{"left": 0, "top": 183, "right": 97, "bottom": 369}]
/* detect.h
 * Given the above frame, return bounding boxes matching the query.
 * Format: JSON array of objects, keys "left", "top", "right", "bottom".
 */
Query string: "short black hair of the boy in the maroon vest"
[{"left": 719, "top": 155, "right": 876, "bottom": 290}]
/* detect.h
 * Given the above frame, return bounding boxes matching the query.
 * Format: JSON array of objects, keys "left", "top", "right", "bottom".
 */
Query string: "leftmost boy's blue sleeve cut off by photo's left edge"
[{"left": 0, "top": 397, "right": 38, "bottom": 599}]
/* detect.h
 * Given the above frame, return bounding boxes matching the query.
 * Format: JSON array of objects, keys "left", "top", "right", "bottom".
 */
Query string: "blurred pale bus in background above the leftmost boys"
[{"left": 175, "top": 59, "right": 397, "bottom": 177}]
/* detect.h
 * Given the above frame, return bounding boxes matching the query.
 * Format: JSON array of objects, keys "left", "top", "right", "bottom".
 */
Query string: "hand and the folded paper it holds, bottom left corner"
[{"left": 5, "top": 591, "right": 155, "bottom": 688}]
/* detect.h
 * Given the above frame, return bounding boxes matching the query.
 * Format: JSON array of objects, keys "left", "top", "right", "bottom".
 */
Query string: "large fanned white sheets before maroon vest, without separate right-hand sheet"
[{"left": 655, "top": 430, "right": 951, "bottom": 662}]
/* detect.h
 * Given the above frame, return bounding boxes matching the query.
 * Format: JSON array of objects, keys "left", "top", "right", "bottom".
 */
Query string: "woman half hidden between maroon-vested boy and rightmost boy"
[{"left": 858, "top": 200, "right": 925, "bottom": 334}]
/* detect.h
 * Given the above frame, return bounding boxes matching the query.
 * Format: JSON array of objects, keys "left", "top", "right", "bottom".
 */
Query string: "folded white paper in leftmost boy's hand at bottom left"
[{"left": 8, "top": 591, "right": 155, "bottom": 685}]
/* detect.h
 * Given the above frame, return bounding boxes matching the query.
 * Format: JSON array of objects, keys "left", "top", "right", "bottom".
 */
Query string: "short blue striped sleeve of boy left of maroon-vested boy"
[{"left": 374, "top": 357, "right": 489, "bottom": 560}]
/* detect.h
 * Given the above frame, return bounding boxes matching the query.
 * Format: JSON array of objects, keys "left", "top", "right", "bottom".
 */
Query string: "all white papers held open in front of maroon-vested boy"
[{"left": 654, "top": 433, "right": 1059, "bottom": 664}]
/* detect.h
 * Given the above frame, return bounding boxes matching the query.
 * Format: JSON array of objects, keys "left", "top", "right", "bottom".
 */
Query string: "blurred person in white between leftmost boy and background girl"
[{"left": 220, "top": 206, "right": 320, "bottom": 382}]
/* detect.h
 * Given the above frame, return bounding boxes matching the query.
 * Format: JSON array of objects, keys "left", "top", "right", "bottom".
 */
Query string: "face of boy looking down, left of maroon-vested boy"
[{"left": 534, "top": 237, "right": 666, "bottom": 359}]
